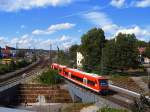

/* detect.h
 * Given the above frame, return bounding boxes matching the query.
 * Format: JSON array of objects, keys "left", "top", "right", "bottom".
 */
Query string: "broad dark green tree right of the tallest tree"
[{"left": 102, "top": 33, "right": 138, "bottom": 70}]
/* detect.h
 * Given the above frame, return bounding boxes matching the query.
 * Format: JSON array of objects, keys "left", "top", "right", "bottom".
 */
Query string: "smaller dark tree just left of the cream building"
[{"left": 69, "top": 44, "right": 79, "bottom": 67}]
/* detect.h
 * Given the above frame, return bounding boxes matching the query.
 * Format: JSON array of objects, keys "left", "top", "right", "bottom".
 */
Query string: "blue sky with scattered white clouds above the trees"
[{"left": 0, "top": 0, "right": 150, "bottom": 49}]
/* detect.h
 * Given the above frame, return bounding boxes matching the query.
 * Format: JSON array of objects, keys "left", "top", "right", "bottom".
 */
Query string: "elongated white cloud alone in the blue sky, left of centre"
[{"left": 32, "top": 23, "right": 75, "bottom": 35}]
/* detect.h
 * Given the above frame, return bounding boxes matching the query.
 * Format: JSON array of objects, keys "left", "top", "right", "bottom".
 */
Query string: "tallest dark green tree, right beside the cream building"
[{"left": 80, "top": 28, "right": 105, "bottom": 72}]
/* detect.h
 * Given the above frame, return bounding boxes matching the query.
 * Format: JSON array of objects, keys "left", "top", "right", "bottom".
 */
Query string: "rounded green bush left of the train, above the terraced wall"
[{"left": 39, "top": 70, "right": 61, "bottom": 85}]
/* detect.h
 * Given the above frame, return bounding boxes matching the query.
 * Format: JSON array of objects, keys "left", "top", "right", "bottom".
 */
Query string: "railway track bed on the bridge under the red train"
[{"left": 65, "top": 78, "right": 149, "bottom": 109}]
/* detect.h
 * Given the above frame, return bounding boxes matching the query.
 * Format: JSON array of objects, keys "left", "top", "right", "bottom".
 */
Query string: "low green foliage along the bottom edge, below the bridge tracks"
[{"left": 97, "top": 106, "right": 128, "bottom": 112}]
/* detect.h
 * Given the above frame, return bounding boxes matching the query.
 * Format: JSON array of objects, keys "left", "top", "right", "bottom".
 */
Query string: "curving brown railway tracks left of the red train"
[{"left": 0, "top": 59, "right": 48, "bottom": 92}]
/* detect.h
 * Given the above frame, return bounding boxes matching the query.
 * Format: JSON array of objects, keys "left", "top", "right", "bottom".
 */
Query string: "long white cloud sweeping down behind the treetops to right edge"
[{"left": 83, "top": 12, "right": 150, "bottom": 41}]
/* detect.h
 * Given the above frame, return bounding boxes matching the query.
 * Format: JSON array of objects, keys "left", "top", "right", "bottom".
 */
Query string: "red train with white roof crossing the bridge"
[{"left": 51, "top": 63, "right": 108, "bottom": 93}]
